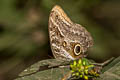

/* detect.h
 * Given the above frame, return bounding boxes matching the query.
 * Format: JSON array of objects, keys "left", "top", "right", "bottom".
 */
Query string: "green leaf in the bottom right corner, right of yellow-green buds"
[{"left": 98, "top": 57, "right": 120, "bottom": 80}]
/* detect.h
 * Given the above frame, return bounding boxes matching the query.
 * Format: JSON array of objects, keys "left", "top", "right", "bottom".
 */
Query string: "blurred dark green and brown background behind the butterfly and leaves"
[{"left": 0, "top": 0, "right": 120, "bottom": 80}]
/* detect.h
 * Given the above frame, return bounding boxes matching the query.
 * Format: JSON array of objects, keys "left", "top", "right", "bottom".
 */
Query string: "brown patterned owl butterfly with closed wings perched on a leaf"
[{"left": 48, "top": 5, "right": 93, "bottom": 60}]
